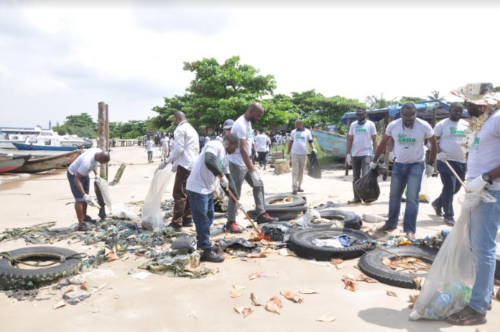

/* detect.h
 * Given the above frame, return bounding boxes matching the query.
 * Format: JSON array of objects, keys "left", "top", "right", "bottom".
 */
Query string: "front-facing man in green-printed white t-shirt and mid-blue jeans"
[{"left": 370, "top": 103, "right": 437, "bottom": 240}]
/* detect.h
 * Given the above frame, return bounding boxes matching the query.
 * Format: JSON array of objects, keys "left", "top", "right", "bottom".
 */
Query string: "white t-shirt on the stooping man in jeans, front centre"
[{"left": 186, "top": 141, "right": 229, "bottom": 195}]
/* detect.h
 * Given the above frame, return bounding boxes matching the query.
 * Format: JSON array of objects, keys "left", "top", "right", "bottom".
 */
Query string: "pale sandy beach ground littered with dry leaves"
[{"left": 0, "top": 147, "right": 500, "bottom": 332}]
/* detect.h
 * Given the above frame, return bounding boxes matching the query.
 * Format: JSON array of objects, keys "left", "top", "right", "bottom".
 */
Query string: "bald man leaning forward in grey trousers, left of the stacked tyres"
[{"left": 226, "top": 103, "right": 277, "bottom": 228}]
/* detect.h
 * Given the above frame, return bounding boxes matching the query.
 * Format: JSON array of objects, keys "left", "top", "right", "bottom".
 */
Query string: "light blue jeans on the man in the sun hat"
[{"left": 469, "top": 190, "right": 500, "bottom": 315}]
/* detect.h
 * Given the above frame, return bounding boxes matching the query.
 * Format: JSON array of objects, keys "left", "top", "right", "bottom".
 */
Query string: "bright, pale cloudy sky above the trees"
[{"left": 0, "top": 0, "right": 500, "bottom": 127}]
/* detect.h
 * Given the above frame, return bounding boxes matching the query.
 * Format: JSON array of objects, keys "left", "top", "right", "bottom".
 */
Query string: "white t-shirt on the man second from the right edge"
[{"left": 434, "top": 119, "right": 469, "bottom": 163}]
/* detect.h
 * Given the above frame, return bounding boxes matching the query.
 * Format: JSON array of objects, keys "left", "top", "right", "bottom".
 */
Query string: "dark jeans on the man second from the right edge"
[{"left": 434, "top": 160, "right": 465, "bottom": 218}]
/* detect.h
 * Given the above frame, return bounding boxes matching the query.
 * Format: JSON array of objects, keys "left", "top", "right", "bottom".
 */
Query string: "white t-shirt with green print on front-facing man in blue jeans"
[{"left": 385, "top": 118, "right": 434, "bottom": 164}]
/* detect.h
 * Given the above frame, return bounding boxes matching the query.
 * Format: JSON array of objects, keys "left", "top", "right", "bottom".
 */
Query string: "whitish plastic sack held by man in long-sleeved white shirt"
[{"left": 141, "top": 167, "right": 174, "bottom": 231}]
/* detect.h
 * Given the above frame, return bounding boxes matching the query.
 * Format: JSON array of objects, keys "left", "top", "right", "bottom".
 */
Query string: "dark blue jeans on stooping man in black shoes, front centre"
[{"left": 187, "top": 190, "right": 214, "bottom": 248}]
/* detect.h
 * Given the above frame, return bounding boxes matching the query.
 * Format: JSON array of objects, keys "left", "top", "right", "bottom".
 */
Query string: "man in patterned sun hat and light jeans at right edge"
[{"left": 446, "top": 83, "right": 500, "bottom": 325}]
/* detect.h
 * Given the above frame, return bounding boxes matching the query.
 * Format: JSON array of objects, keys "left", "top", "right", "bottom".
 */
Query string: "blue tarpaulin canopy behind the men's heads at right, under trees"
[{"left": 342, "top": 100, "right": 469, "bottom": 125}]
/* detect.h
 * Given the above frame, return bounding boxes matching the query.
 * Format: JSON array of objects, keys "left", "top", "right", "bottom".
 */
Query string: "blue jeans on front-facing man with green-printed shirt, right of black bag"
[{"left": 386, "top": 162, "right": 425, "bottom": 233}]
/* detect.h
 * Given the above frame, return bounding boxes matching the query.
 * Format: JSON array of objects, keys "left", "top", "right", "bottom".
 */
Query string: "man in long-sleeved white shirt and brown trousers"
[{"left": 158, "top": 111, "right": 200, "bottom": 232}]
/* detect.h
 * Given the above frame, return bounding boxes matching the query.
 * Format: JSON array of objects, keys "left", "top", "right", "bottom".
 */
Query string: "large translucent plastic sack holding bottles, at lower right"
[{"left": 410, "top": 191, "right": 496, "bottom": 320}]
